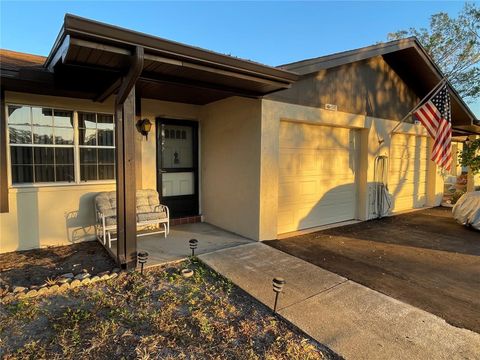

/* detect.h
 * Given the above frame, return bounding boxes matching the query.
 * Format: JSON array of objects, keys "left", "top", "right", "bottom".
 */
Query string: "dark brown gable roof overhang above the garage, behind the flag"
[{"left": 281, "top": 37, "right": 480, "bottom": 134}]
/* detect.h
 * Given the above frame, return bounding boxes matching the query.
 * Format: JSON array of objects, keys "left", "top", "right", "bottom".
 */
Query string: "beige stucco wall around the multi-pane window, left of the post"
[{"left": 0, "top": 92, "right": 115, "bottom": 253}]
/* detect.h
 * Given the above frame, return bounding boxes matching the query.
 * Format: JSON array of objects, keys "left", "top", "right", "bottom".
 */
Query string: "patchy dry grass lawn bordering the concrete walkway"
[{"left": 0, "top": 260, "right": 332, "bottom": 359}]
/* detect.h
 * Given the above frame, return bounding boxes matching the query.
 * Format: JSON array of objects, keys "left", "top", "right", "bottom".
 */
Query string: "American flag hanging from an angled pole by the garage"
[{"left": 413, "top": 84, "right": 452, "bottom": 171}]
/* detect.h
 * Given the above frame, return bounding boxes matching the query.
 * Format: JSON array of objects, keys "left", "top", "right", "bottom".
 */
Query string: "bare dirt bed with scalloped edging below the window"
[{"left": 0, "top": 241, "right": 115, "bottom": 287}]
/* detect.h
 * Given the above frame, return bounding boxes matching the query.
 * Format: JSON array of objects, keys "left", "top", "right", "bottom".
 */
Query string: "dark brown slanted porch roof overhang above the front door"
[{"left": 35, "top": 14, "right": 298, "bottom": 104}]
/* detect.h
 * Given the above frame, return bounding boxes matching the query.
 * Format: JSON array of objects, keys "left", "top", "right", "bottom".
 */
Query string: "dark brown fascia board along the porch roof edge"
[{"left": 45, "top": 14, "right": 298, "bottom": 84}]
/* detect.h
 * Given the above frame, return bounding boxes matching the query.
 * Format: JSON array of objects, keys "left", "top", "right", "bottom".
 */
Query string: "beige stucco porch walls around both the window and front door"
[{"left": 0, "top": 92, "right": 261, "bottom": 253}]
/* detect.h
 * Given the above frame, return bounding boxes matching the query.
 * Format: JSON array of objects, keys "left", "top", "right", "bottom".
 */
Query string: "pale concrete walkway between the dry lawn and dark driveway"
[{"left": 199, "top": 243, "right": 480, "bottom": 360}]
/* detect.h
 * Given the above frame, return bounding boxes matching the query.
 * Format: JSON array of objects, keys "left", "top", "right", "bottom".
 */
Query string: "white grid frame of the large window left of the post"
[{"left": 4, "top": 102, "right": 116, "bottom": 188}]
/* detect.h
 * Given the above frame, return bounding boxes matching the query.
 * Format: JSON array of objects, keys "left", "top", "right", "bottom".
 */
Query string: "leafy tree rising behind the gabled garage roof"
[{"left": 388, "top": 3, "right": 480, "bottom": 100}]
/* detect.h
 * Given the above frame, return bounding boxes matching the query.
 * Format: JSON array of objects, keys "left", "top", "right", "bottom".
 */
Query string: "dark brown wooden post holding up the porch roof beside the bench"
[{"left": 115, "top": 47, "right": 143, "bottom": 269}]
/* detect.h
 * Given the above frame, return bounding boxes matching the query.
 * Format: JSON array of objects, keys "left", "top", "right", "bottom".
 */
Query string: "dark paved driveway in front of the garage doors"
[{"left": 266, "top": 207, "right": 480, "bottom": 333}]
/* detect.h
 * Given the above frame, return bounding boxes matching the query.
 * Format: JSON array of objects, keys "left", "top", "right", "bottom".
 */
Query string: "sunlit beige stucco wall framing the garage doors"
[{"left": 259, "top": 100, "right": 443, "bottom": 240}]
